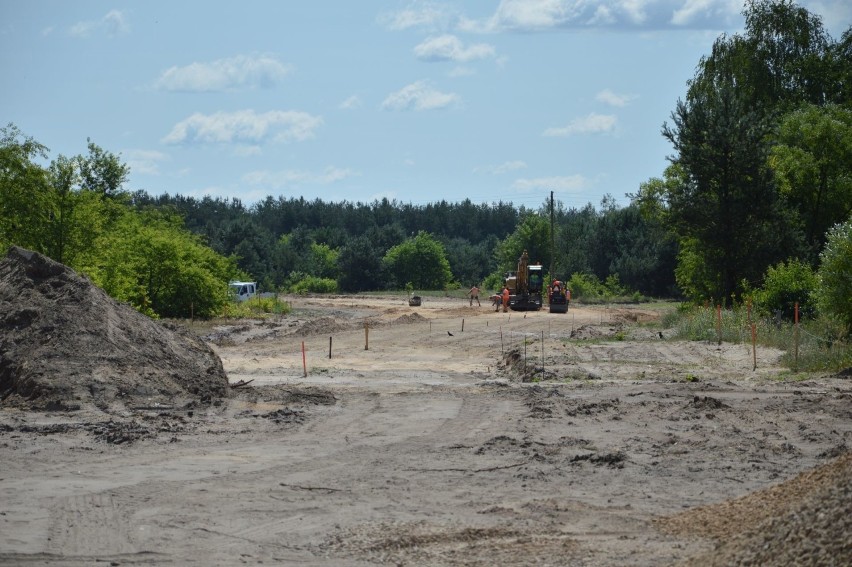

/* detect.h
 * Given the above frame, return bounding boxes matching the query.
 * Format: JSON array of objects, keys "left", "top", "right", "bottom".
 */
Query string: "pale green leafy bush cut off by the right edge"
[{"left": 814, "top": 217, "right": 852, "bottom": 336}]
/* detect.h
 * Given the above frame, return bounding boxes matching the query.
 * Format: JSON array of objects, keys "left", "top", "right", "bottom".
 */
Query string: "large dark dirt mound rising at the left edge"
[{"left": 0, "top": 247, "right": 228, "bottom": 410}]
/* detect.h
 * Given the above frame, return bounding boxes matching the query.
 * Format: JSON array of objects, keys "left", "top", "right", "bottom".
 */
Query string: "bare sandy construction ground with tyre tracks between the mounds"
[{"left": 0, "top": 296, "right": 852, "bottom": 566}]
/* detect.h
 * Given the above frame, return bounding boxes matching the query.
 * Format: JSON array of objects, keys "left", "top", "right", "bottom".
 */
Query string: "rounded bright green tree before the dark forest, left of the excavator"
[{"left": 382, "top": 231, "right": 452, "bottom": 290}]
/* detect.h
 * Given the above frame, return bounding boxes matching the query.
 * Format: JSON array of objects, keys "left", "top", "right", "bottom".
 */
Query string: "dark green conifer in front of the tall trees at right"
[{"left": 663, "top": 84, "right": 790, "bottom": 304}]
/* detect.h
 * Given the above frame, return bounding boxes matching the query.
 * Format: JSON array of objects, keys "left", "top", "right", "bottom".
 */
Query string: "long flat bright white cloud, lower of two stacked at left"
[{"left": 162, "top": 110, "right": 323, "bottom": 144}]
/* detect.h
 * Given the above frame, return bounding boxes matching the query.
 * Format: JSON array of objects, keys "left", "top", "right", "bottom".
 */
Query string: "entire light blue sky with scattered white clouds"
[{"left": 0, "top": 0, "right": 852, "bottom": 208}]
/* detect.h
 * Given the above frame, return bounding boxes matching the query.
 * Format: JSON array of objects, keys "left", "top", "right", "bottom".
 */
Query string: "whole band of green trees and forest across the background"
[{"left": 0, "top": 0, "right": 852, "bottom": 336}]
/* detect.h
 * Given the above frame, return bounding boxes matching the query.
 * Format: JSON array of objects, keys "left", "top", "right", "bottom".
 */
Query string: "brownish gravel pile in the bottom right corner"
[{"left": 658, "top": 453, "right": 852, "bottom": 566}]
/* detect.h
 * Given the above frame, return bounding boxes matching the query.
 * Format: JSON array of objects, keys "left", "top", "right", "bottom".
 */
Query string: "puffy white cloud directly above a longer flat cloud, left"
[{"left": 156, "top": 55, "right": 290, "bottom": 92}]
